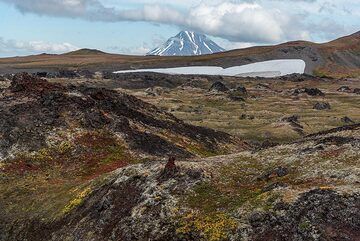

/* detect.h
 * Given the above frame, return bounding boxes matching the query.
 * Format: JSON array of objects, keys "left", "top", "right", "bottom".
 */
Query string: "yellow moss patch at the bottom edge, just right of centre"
[{"left": 176, "top": 212, "right": 237, "bottom": 241}]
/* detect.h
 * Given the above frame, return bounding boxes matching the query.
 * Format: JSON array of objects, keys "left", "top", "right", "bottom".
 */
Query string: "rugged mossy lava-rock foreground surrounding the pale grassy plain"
[{"left": 0, "top": 74, "right": 360, "bottom": 241}]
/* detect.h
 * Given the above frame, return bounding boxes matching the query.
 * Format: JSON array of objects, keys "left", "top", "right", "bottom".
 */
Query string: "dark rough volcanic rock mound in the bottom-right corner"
[{"left": 250, "top": 189, "right": 360, "bottom": 241}]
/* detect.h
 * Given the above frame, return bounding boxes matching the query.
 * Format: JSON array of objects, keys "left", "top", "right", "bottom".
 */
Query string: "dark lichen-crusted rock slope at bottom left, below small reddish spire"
[{"left": 0, "top": 163, "right": 204, "bottom": 241}]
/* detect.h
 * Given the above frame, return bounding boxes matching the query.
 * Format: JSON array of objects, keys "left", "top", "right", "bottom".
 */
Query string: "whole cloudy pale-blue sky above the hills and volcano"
[{"left": 0, "top": 0, "right": 360, "bottom": 57}]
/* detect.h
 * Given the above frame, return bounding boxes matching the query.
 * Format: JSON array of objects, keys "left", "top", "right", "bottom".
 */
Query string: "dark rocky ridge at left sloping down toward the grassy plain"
[{"left": 0, "top": 74, "right": 242, "bottom": 160}]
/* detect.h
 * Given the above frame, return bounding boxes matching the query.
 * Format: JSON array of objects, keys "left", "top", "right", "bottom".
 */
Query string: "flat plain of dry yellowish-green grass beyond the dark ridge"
[{"left": 124, "top": 78, "right": 360, "bottom": 142}]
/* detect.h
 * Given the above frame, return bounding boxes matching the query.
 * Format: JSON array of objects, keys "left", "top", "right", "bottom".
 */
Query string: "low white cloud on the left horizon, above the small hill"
[{"left": 0, "top": 37, "right": 79, "bottom": 55}]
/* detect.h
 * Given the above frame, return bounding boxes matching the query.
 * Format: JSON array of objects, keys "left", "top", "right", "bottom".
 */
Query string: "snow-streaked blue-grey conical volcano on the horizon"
[{"left": 147, "top": 31, "right": 225, "bottom": 56}]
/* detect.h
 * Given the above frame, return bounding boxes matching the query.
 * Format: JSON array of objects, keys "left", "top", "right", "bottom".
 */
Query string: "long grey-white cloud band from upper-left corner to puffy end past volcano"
[{"left": 0, "top": 0, "right": 306, "bottom": 43}]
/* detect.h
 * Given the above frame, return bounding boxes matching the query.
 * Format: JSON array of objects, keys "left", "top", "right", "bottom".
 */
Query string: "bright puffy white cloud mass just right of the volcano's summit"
[{"left": 186, "top": 2, "right": 286, "bottom": 43}]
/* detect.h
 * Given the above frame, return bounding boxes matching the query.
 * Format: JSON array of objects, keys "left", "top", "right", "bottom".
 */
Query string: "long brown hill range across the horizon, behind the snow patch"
[{"left": 0, "top": 30, "right": 360, "bottom": 76}]
